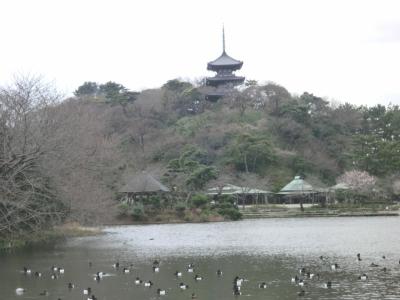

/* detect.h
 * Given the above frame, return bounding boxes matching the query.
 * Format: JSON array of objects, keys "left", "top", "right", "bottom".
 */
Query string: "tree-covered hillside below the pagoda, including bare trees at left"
[{"left": 0, "top": 77, "right": 400, "bottom": 239}]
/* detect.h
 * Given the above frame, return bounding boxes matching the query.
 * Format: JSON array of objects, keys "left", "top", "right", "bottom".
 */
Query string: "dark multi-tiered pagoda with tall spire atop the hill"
[{"left": 206, "top": 28, "right": 245, "bottom": 101}]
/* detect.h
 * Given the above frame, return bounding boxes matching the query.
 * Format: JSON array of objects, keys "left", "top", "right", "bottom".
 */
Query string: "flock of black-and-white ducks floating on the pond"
[{"left": 15, "top": 253, "right": 400, "bottom": 300}]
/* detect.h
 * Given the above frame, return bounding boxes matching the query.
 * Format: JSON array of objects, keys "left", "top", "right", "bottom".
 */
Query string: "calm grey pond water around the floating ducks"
[{"left": 0, "top": 217, "right": 400, "bottom": 300}]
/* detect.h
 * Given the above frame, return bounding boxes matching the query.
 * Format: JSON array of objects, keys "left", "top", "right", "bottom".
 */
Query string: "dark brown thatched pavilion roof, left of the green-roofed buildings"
[{"left": 119, "top": 173, "right": 170, "bottom": 196}]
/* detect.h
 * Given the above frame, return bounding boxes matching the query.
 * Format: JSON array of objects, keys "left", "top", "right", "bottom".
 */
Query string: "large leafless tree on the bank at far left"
[{"left": 0, "top": 76, "right": 63, "bottom": 236}]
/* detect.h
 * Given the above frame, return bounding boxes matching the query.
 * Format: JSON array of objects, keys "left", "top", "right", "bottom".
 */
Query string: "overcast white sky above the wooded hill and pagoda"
[{"left": 0, "top": 0, "right": 400, "bottom": 105}]
